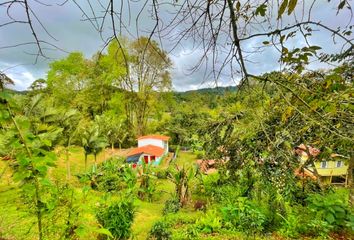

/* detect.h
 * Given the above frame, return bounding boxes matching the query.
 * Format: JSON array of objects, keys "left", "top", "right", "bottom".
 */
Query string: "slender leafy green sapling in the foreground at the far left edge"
[{"left": 0, "top": 78, "right": 56, "bottom": 240}]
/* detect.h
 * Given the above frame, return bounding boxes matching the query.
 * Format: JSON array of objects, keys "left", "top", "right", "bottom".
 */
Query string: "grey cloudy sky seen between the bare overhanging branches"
[{"left": 0, "top": 0, "right": 353, "bottom": 91}]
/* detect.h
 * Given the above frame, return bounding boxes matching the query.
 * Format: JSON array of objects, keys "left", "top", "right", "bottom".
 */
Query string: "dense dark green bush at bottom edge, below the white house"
[{"left": 96, "top": 200, "right": 135, "bottom": 239}]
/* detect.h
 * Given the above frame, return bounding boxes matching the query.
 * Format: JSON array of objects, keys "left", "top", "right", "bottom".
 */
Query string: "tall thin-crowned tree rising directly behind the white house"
[{"left": 100, "top": 37, "right": 172, "bottom": 135}]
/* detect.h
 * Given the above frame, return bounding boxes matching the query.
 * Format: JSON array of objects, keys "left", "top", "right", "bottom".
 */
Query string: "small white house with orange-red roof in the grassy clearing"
[{"left": 127, "top": 135, "right": 170, "bottom": 166}]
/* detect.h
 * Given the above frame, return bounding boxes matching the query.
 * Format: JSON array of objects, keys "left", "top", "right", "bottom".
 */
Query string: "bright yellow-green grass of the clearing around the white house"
[{"left": 0, "top": 147, "right": 196, "bottom": 240}]
